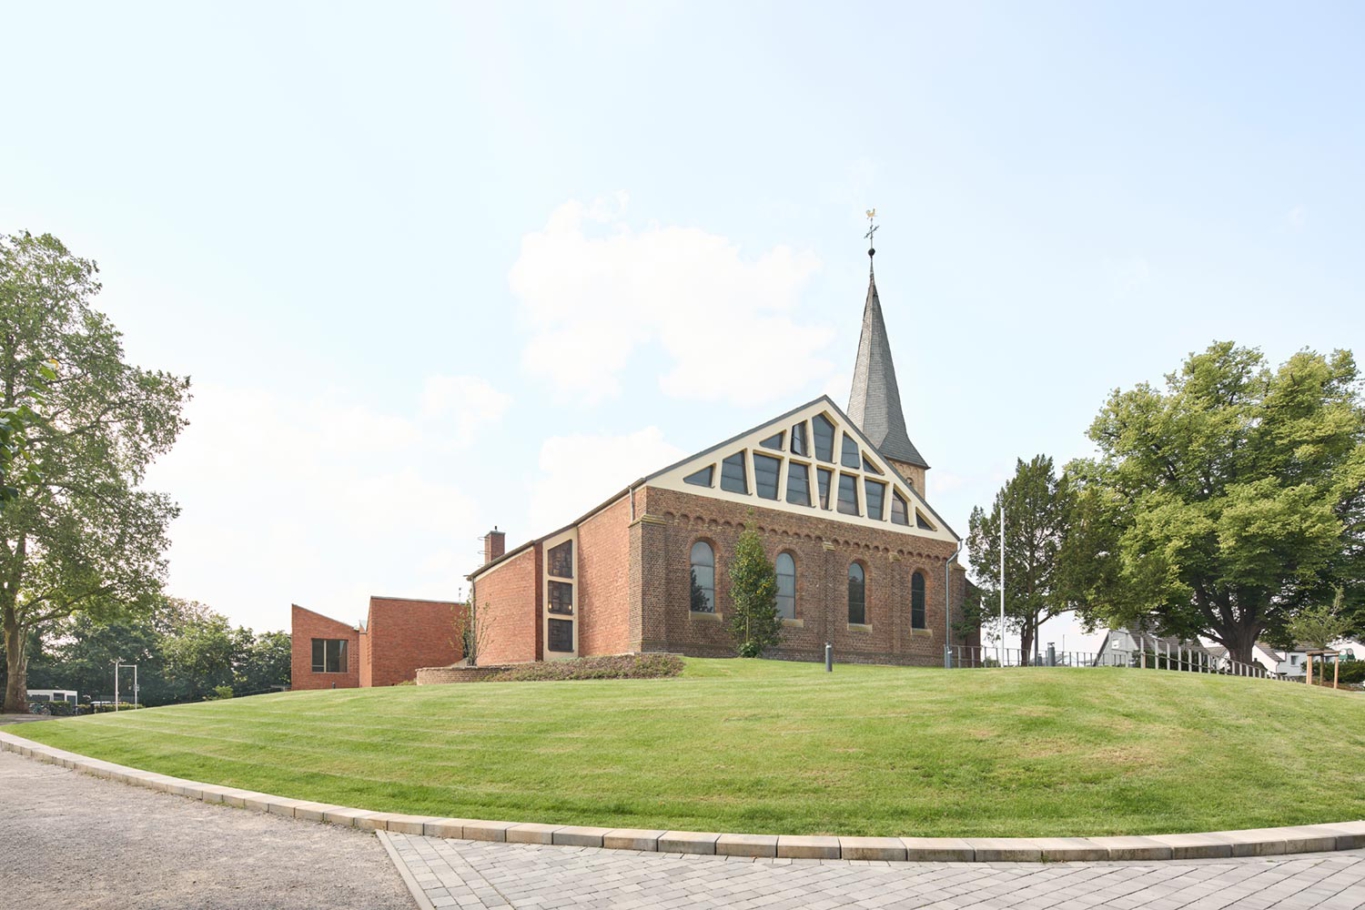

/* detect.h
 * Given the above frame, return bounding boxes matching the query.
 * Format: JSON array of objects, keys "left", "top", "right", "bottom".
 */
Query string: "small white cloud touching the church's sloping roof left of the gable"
[{"left": 531, "top": 427, "right": 687, "bottom": 535}]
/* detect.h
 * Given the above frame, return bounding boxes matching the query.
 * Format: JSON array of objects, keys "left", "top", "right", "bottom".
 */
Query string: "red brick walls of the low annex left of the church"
[{"left": 291, "top": 598, "right": 464, "bottom": 689}]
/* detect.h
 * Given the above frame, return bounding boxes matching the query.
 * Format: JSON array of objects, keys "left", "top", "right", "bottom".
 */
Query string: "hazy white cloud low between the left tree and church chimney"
[{"left": 147, "top": 377, "right": 508, "bottom": 629}]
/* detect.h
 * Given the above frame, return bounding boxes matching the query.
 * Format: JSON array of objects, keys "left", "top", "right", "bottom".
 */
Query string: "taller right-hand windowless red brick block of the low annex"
[{"left": 360, "top": 598, "right": 464, "bottom": 686}]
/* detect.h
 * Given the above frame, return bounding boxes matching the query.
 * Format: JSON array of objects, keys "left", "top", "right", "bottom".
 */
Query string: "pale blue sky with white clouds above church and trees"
[{"left": 0, "top": 0, "right": 1365, "bottom": 649}]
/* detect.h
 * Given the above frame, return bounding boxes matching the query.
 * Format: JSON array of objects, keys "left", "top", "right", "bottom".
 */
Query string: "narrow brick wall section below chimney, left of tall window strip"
[{"left": 474, "top": 544, "right": 541, "bottom": 663}]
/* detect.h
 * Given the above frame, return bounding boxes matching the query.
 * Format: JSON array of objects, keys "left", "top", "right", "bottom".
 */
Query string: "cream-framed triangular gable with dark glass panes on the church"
[{"left": 644, "top": 396, "right": 958, "bottom": 543}]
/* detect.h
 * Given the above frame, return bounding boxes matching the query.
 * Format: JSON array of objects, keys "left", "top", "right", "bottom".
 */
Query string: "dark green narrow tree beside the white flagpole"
[{"left": 968, "top": 456, "right": 1073, "bottom": 659}]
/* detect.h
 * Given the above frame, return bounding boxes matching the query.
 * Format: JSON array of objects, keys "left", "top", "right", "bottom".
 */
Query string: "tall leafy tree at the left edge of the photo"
[{"left": 0, "top": 233, "right": 190, "bottom": 711}]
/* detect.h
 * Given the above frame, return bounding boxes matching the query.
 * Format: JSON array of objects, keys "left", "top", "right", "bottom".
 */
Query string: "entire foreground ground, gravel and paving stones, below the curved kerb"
[{"left": 0, "top": 753, "right": 1365, "bottom": 910}]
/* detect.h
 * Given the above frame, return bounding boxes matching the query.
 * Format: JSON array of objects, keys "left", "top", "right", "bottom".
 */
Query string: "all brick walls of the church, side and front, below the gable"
[{"left": 472, "top": 486, "right": 975, "bottom": 666}]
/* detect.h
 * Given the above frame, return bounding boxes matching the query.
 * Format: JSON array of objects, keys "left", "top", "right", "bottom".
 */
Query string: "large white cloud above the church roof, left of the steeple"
[{"left": 508, "top": 194, "right": 834, "bottom": 405}]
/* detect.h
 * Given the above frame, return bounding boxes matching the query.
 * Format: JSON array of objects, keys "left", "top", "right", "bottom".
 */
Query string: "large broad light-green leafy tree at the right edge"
[{"left": 1065, "top": 342, "right": 1365, "bottom": 663}]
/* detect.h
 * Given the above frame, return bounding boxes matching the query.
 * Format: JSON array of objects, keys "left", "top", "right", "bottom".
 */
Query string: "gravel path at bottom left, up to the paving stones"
[{"left": 0, "top": 752, "right": 414, "bottom": 910}]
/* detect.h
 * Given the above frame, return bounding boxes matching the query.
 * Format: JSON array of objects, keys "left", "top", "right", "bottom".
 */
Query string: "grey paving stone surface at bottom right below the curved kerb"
[{"left": 381, "top": 832, "right": 1365, "bottom": 910}]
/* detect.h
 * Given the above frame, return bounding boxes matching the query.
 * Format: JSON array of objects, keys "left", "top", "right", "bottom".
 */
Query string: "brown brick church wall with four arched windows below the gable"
[{"left": 631, "top": 487, "right": 962, "bottom": 666}]
